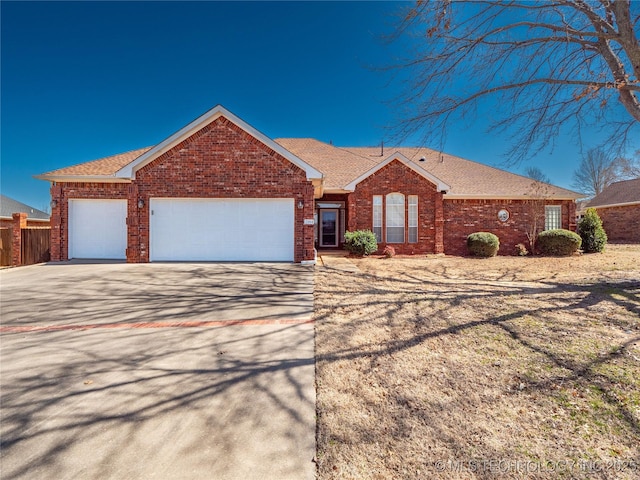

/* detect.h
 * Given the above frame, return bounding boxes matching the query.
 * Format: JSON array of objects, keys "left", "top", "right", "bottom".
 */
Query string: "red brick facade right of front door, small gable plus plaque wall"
[{"left": 323, "top": 160, "right": 576, "bottom": 255}]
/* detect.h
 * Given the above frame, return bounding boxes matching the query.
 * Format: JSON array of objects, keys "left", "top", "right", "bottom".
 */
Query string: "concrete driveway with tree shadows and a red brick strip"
[{"left": 0, "top": 263, "right": 315, "bottom": 480}]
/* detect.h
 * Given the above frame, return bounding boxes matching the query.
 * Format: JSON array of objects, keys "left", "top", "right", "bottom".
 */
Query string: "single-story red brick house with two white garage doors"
[{"left": 37, "top": 106, "right": 580, "bottom": 263}]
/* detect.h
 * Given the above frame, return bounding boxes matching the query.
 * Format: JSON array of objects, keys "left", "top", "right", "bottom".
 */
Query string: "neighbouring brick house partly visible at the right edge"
[{"left": 586, "top": 178, "right": 640, "bottom": 243}]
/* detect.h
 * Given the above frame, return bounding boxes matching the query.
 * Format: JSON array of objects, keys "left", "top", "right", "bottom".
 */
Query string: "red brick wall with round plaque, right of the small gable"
[{"left": 444, "top": 197, "right": 575, "bottom": 255}]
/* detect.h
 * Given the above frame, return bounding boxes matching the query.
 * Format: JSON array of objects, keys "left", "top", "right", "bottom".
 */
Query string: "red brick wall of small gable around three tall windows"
[{"left": 347, "top": 160, "right": 441, "bottom": 254}]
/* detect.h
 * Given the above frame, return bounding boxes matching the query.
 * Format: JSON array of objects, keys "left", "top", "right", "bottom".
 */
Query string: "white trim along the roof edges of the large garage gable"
[{"left": 115, "top": 105, "right": 322, "bottom": 180}]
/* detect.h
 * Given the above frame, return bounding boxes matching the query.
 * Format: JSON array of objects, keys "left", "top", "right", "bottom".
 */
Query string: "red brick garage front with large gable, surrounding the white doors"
[{"left": 51, "top": 117, "right": 314, "bottom": 262}]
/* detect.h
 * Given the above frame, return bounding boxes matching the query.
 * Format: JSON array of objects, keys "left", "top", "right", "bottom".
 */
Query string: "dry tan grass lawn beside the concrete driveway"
[{"left": 315, "top": 245, "right": 640, "bottom": 480}]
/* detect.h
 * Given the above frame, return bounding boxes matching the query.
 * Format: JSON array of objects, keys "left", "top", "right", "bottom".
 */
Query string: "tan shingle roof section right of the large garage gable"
[{"left": 276, "top": 138, "right": 582, "bottom": 199}]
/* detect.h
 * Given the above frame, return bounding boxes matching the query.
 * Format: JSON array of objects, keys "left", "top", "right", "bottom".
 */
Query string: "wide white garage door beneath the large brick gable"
[{"left": 149, "top": 198, "right": 294, "bottom": 262}]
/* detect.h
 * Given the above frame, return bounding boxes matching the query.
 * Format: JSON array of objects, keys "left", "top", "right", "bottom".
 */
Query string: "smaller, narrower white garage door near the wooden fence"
[{"left": 69, "top": 199, "right": 127, "bottom": 259}]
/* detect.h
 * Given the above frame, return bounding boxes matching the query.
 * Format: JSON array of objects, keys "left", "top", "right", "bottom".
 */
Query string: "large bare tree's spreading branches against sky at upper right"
[{"left": 395, "top": 0, "right": 640, "bottom": 163}]
